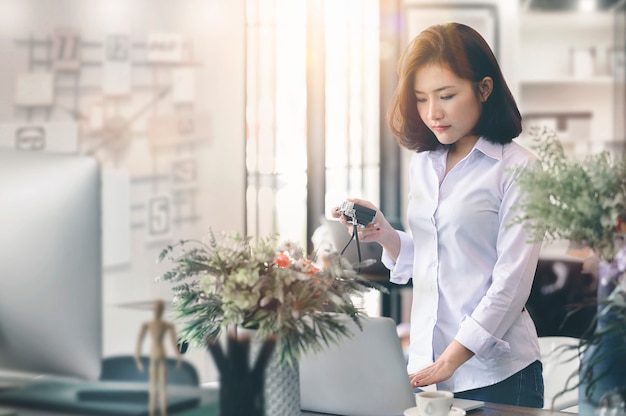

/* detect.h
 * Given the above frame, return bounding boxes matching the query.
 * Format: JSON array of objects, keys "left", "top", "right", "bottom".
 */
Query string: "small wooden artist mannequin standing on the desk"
[{"left": 135, "top": 300, "right": 183, "bottom": 416}]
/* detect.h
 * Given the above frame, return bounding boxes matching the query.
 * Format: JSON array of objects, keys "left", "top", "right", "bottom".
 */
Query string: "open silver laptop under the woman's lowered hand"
[{"left": 300, "top": 317, "right": 415, "bottom": 416}]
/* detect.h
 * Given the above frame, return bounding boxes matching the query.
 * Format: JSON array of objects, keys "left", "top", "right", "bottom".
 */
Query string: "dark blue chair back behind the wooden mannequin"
[{"left": 100, "top": 355, "right": 200, "bottom": 386}]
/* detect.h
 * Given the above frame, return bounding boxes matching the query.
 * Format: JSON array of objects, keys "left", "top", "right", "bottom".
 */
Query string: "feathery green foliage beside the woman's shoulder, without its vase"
[{"left": 514, "top": 128, "right": 626, "bottom": 259}]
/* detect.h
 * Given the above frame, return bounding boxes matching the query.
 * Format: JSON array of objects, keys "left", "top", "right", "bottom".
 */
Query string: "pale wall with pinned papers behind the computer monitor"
[{"left": 0, "top": 0, "right": 245, "bottom": 381}]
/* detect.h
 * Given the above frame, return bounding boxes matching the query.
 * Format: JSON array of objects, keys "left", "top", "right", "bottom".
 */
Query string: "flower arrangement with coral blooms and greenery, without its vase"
[{"left": 159, "top": 232, "right": 386, "bottom": 363}]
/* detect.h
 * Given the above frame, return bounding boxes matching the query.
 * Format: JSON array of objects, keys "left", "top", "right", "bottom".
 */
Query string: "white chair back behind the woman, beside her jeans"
[{"left": 539, "top": 336, "right": 580, "bottom": 411}]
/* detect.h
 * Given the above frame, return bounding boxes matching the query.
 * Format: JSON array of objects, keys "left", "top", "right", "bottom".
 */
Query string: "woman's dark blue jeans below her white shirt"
[{"left": 454, "top": 361, "right": 543, "bottom": 408}]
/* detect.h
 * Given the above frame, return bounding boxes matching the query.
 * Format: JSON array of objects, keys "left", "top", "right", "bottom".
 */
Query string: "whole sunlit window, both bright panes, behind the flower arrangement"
[{"left": 246, "top": 0, "right": 380, "bottom": 245}]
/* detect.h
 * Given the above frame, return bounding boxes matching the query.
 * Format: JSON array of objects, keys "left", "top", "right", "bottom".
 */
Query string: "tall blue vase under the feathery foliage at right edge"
[{"left": 578, "top": 255, "right": 626, "bottom": 415}]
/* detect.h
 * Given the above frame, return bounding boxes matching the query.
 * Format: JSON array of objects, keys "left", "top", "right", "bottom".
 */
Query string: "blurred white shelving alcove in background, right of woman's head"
[{"left": 519, "top": 11, "right": 624, "bottom": 158}]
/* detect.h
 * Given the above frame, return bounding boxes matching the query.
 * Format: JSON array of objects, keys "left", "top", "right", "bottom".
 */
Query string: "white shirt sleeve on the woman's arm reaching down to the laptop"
[{"left": 455, "top": 158, "right": 541, "bottom": 358}]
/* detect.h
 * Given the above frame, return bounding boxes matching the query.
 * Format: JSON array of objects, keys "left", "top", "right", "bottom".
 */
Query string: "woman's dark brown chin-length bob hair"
[{"left": 388, "top": 23, "right": 522, "bottom": 152}]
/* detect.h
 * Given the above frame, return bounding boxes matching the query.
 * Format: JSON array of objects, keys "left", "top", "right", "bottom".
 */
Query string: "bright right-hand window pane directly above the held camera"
[{"left": 325, "top": 0, "right": 380, "bottom": 212}]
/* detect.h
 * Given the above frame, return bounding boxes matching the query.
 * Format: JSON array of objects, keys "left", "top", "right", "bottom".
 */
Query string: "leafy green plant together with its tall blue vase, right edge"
[{"left": 514, "top": 128, "right": 626, "bottom": 414}]
